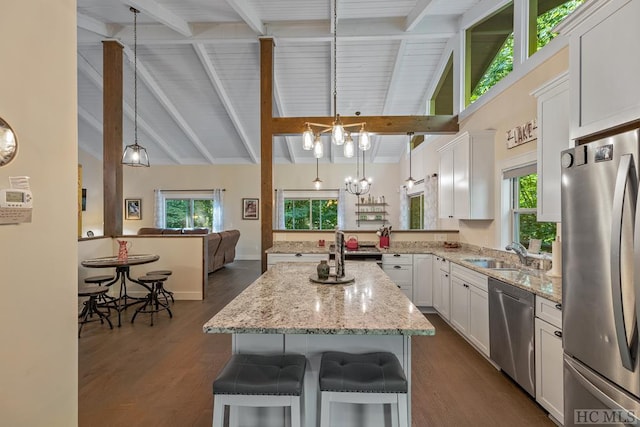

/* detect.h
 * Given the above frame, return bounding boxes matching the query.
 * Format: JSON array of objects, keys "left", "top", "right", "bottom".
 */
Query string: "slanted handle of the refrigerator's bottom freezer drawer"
[{"left": 564, "top": 356, "right": 639, "bottom": 421}]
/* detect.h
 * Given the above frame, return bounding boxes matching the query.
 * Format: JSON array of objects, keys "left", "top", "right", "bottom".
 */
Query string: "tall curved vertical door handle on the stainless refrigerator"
[{"left": 610, "top": 154, "right": 638, "bottom": 372}]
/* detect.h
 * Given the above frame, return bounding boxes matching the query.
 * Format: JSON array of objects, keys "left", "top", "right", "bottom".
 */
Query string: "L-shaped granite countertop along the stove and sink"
[{"left": 266, "top": 241, "right": 562, "bottom": 303}]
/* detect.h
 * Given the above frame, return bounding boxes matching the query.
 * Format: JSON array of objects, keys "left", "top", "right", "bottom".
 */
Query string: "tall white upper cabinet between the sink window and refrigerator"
[{"left": 533, "top": 72, "right": 571, "bottom": 222}]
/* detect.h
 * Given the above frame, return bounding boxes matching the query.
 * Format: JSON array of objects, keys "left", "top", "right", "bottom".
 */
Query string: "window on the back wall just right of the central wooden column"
[{"left": 284, "top": 197, "right": 338, "bottom": 230}]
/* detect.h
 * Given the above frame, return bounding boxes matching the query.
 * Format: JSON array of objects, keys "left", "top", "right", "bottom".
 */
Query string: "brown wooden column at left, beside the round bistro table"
[{"left": 102, "top": 40, "right": 123, "bottom": 236}]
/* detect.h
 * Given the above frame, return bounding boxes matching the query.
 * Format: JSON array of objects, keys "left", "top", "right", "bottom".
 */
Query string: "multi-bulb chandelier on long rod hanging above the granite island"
[{"left": 302, "top": 0, "right": 371, "bottom": 158}]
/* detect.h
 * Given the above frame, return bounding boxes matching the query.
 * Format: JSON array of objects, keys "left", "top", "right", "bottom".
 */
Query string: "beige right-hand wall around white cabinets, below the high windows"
[{"left": 402, "top": 48, "right": 569, "bottom": 248}]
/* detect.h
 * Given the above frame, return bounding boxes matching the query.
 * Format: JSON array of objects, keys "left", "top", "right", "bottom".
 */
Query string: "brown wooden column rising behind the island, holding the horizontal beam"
[{"left": 260, "top": 38, "right": 273, "bottom": 272}]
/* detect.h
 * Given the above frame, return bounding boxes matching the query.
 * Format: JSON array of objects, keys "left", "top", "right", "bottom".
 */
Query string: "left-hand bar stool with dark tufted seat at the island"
[{"left": 213, "top": 354, "right": 307, "bottom": 427}]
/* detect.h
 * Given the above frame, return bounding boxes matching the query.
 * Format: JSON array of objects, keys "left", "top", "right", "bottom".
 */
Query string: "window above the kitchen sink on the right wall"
[{"left": 504, "top": 165, "right": 556, "bottom": 252}]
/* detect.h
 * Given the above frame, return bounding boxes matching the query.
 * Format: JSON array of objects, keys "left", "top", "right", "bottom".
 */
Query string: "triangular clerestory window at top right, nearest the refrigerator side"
[{"left": 529, "top": 0, "right": 584, "bottom": 56}]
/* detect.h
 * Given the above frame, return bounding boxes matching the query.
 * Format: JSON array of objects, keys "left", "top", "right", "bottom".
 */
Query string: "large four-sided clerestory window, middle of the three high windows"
[{"left": 465, "top": 3, "right": 513, "bottom": 105}]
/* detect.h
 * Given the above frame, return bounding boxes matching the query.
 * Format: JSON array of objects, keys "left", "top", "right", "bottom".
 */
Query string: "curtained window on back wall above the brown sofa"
[{"left": 156, "top": 190, "right": 222, "bottom": 230}]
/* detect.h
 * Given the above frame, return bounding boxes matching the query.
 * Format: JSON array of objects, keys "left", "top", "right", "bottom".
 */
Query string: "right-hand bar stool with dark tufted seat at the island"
[{"left": 320, "top": 351, "right": 409, "bottom": 427}]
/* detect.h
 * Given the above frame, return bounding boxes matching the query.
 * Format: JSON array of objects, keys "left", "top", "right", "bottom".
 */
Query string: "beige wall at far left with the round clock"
[{"left": 0, "top": 0, "right": 78, "bottom": 427}]
